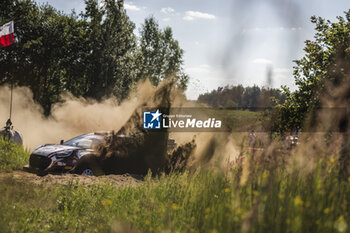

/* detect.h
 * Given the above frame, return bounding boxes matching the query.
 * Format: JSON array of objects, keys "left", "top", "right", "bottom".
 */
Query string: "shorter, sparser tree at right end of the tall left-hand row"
[{"left": 139, "top": 16, "right": 189, "bottom": 89}]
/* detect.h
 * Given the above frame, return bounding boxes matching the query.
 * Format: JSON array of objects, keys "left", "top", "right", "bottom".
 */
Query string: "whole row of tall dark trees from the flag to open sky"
[{"left": 0, "top": 0, "right": 188, "bottom": 115}]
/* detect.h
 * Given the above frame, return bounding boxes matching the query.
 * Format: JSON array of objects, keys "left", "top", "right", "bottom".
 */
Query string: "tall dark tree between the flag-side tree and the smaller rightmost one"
[{"left": 84, "top": 0, "right": 136, "bottom": 99}]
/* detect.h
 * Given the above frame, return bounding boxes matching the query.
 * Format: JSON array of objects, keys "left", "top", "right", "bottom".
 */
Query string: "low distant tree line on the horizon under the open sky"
[{"left": 197, "top": 85, "right": 285, "bottom": 109}]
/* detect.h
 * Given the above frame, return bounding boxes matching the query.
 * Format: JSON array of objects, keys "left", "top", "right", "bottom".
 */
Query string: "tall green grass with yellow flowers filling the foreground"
[{"left": 0, "top": 135, "right": 350, "bottom": 232}]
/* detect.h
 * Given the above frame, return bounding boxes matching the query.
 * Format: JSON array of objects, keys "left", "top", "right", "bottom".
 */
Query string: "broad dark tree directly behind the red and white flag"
[{"left": 0, "top": 0, "right": 90, "bottom": 114}]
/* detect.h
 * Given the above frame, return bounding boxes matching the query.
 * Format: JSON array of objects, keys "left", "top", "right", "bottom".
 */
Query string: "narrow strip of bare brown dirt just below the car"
[{"left": 0, "top": 171, "right": 143, "bottom": 187}]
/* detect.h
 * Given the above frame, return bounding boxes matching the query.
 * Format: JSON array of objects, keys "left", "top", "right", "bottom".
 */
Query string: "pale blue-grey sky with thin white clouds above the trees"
[{"left": 36, "top": 0, "right": 350, "bottom": 99}]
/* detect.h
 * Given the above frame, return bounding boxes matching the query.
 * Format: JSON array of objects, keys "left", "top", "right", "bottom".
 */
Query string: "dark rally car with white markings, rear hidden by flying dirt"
[{"left": 24, "top": 131, "right": 176, "bottom": 175}]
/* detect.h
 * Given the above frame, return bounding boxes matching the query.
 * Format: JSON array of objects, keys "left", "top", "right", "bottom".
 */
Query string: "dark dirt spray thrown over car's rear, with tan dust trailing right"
[{"left": 96, "top": 79, "right": 239, "bottom": 174}]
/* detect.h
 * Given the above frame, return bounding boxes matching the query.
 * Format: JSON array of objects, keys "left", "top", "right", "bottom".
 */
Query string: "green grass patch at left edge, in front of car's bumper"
[{"left": 0, "top": 136, "right": 29, "bottom": 172}]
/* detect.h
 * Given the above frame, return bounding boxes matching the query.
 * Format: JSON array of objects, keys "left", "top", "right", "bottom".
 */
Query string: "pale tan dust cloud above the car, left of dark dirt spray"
[{"left": 0, "top": 81, "right": 153, "bottom": 149}]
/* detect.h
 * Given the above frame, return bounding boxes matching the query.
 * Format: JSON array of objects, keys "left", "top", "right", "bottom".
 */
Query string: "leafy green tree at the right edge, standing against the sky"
[{"left": 273, "top": 10, "right": 350, "bottom": 132}]
